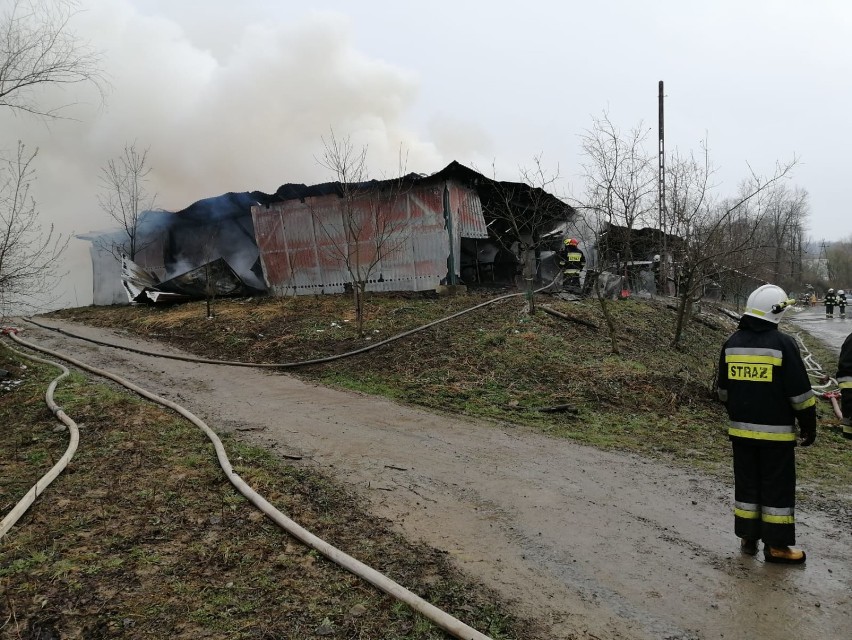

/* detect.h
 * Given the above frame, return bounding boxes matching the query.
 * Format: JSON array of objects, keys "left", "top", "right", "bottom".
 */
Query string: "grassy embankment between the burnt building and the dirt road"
[{"left": 48, "top": 294, "right": 852, "bottom": 492}]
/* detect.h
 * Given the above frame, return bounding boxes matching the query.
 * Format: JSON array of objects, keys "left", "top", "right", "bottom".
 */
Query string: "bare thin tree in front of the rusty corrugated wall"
[{"left": 312, "top": 130, "right": 409, "bottom": 335}]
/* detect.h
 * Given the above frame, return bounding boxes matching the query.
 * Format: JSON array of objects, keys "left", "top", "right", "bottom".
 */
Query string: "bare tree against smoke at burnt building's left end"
[{"left": 98, "top": 143, "right": 156, "bottom": 260}]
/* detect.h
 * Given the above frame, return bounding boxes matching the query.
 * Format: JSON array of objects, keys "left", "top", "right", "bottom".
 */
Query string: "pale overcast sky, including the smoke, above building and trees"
[{"left": 0, "top": 0, "right": 852, "bottom": 305}]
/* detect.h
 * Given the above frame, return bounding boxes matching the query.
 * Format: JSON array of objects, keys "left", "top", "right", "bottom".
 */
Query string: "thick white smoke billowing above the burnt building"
[{"left": 0, "top": 0, "right": 487, "bottom": 306}]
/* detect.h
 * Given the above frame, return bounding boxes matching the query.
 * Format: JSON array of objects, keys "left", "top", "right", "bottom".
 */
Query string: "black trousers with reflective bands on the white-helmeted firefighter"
[{"left": 731, "top": 438, "right": 796, "bottom": 547}]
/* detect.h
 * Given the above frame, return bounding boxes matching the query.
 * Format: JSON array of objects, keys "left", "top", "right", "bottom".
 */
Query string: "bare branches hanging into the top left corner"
[{"left": 0, "top": 0, "right": 105, "bottom": 118}]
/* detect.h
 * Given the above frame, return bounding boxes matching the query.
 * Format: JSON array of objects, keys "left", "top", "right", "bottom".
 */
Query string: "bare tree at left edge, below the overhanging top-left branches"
[{"left": 0, "top": 142, "right": 68, "bottom": 315}]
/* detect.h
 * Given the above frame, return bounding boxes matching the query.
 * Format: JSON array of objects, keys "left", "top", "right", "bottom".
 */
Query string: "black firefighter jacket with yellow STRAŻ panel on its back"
[{"left": 717, "top": 316, "right": 816, "bottom": 445}]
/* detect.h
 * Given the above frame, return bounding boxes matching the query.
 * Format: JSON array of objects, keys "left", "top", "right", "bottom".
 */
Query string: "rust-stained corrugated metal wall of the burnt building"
[{"left": 252, "top": 181, "right": 488, "bottom": 295}]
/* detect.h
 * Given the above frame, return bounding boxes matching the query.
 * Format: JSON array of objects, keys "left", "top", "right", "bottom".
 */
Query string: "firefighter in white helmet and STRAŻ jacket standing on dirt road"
[{"left": 717, "top": 285, "right": 816, "bottom": 564}]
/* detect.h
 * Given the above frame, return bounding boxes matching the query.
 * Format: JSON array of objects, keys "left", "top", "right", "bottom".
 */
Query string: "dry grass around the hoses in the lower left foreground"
[{"left": 0, "top": 347, "right": 529, "bottom": 640}]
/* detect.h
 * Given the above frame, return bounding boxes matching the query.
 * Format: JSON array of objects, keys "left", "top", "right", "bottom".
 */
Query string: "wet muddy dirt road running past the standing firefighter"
[{"left": 15, "top": 320, "right": 852, "bottom": 640}]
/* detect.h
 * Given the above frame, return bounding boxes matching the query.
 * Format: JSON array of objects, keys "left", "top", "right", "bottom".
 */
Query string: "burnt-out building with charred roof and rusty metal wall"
[{"left": 83, "top": 162, "right": 576, "bottom": 305}]
